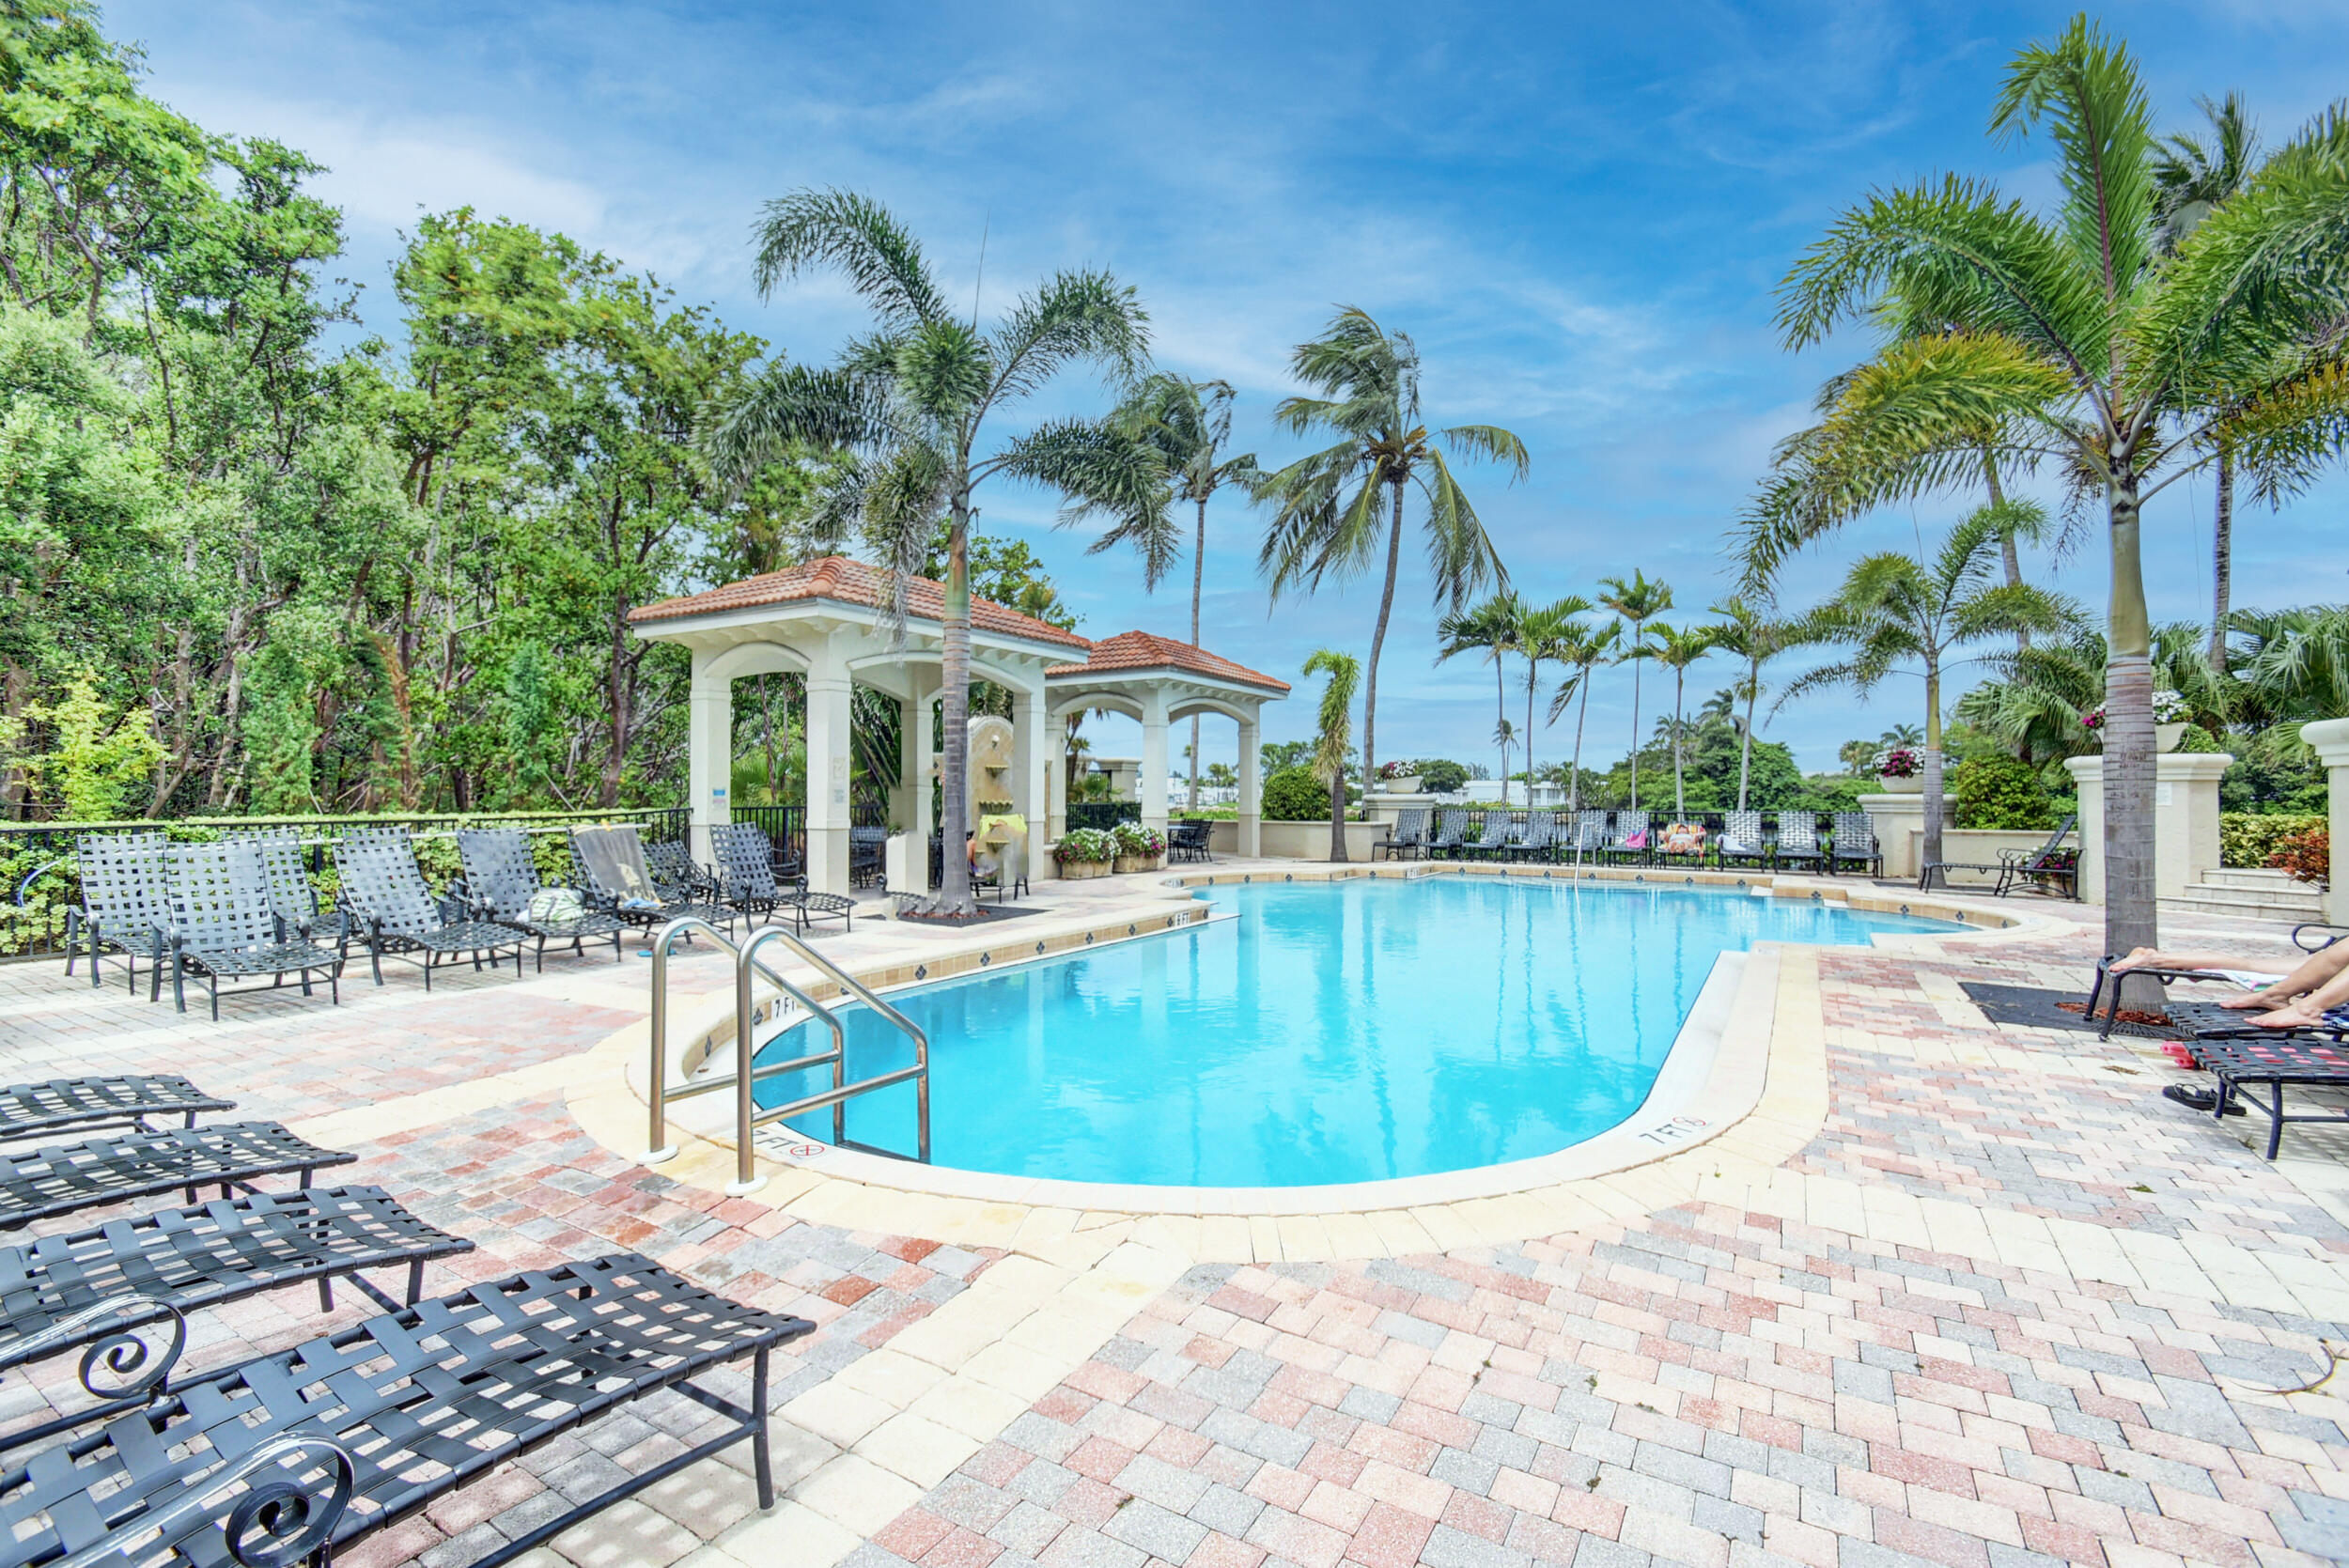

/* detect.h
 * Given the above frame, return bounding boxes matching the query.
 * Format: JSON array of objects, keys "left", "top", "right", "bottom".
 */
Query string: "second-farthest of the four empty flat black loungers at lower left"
[{"left": 0, "top": 1122, "right": 357, "bottom": 1230}]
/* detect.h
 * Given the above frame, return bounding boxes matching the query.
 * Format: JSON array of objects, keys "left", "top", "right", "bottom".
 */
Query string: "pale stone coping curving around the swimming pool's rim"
[{"left": 568, "top": 863, "right": 2070, "bottom": 1261}]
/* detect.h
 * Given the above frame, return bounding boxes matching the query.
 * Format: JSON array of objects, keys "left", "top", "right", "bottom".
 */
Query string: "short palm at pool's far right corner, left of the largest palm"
[{"left": 1771, "top": 507, "right": 2067, "bottom": 862}]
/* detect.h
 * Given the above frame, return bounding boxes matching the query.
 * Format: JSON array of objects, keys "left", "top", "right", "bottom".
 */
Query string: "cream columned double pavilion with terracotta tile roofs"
[{"left": 628, "top": 556, "right": 1290, "bottom": 892}]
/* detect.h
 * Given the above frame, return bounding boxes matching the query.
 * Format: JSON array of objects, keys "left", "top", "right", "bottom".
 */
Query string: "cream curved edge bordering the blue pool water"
[{"left": 568, "top": 866, "right": 2072, "bottom": 1263}]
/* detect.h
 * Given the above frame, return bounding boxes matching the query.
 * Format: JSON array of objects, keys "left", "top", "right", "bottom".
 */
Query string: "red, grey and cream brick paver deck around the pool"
[{"left": 0, "top": 877, "right": 2349, "bottom": 1568}]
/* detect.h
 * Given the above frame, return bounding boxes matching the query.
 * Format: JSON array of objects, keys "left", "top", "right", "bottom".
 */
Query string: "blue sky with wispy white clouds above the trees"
[{"left": 108, "top": 0, "right": 2349, "bottom": 768}]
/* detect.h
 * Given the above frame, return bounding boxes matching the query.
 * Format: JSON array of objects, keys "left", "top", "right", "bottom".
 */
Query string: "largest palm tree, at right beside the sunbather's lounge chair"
[{"left": 1748, "top": 16, "right": 2349, "bottom": 995}]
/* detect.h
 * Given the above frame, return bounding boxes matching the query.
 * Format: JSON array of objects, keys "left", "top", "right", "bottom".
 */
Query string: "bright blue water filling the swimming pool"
[{"left": 759, "top": 876, "right": 1962, "bottom": 1188}]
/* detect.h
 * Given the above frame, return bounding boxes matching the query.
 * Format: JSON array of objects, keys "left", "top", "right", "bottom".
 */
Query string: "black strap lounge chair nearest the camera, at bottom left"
[{"left": 0, "top": 1256, "right": 816, "bottom": 1568}]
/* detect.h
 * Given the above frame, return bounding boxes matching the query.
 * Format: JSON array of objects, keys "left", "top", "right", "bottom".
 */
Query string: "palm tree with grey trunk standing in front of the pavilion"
[{"left": 703, "top": 190, "right": 1168, "bottom": 913}]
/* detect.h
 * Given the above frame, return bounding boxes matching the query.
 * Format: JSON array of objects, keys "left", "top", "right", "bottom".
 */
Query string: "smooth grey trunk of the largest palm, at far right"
[{"left": 2105, "top": 469, "right": 2161, "bottom": 1007}]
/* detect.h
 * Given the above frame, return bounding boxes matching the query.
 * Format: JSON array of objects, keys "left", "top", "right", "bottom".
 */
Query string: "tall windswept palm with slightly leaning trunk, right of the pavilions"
[{"left": 1257, "top": 307, "right": 1530, "bottom": 777}]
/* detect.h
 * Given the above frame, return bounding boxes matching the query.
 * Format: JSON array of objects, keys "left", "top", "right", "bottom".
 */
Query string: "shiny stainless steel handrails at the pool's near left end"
[{"left": 639, "top": 915, "right": 930, "bottom": 1197}]
